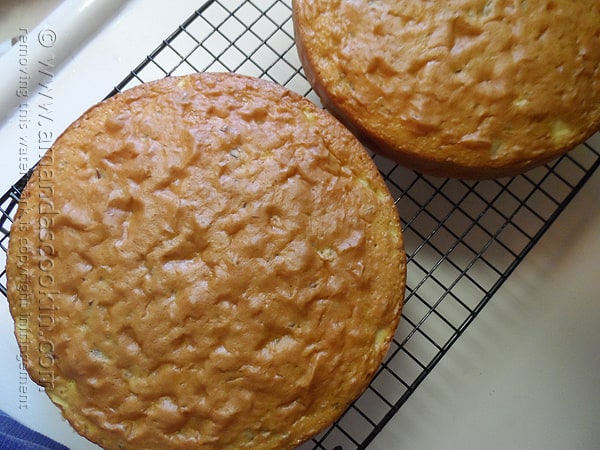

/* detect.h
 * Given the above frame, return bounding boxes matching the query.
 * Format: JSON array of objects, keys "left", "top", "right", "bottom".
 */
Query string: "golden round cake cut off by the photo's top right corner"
[{"left": 293, "top": 0, "right": 600, "bottom": 178}]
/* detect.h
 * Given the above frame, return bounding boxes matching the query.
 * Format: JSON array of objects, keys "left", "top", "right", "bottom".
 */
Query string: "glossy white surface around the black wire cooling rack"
[{"left": 0, "top": 0, "right": 600, "bottom": 450}]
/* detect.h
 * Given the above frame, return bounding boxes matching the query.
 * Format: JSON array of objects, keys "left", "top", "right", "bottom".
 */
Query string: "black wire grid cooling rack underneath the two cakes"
[{"left": 0, "top": 0, "right": 600, "bottom": 450}]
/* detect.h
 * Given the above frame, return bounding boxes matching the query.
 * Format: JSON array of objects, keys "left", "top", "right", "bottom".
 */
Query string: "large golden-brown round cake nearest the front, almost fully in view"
[{"left": 7, "top": 73, "right": 406, "bottom": 449}]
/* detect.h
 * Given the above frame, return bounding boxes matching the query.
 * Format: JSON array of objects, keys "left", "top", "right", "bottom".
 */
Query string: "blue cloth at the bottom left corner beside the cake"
[{"left": 0, "top": 410, "right": 69, "bottom": 450}]
